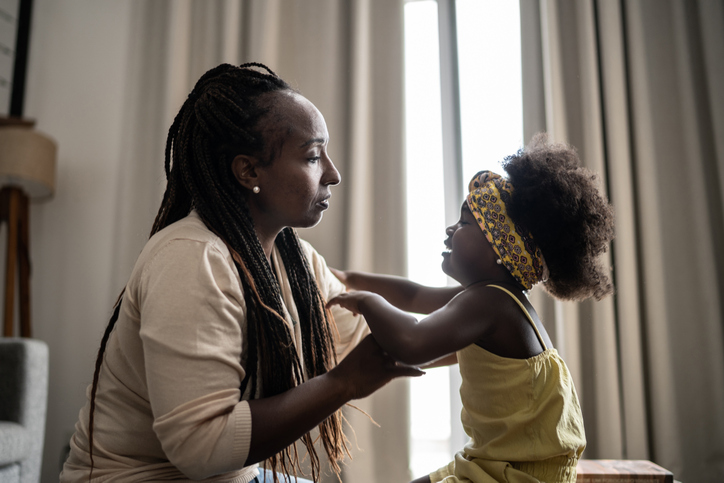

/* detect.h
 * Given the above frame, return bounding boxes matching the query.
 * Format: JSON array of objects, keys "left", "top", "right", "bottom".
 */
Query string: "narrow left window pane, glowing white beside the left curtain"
[{"left": 405, "top": 1, "right": 450, "bottom": 478}]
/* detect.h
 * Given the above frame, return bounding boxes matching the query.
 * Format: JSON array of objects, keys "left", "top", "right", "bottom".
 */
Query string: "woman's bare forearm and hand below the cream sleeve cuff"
[{"left": 246, "top": 336, "right": 424, "bottom": 465}]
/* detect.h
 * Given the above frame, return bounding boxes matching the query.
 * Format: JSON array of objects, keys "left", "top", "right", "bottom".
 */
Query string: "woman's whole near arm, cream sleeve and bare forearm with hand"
[{"left": 139, "top": 237, "right": 422, "bottom": 479}]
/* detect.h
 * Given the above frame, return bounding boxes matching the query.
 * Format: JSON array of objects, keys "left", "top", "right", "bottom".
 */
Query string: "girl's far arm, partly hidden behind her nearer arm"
[{"left": 330, "top": 268, "right": 463, "bottom": 314}]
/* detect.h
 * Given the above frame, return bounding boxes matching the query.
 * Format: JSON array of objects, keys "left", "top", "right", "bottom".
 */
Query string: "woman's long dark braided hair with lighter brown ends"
[{"left": 89, "top": 63, "right": 349, "bottom": 482}]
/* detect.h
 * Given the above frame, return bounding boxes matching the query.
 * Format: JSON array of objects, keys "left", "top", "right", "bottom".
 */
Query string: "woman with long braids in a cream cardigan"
[{"left": 61, "top": 64, "right": 421, "bottom": 483}]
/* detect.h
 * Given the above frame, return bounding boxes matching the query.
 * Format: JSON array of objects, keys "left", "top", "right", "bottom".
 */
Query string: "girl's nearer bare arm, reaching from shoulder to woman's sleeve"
[{"left": 328, "top": 290, "right": 495, "bottom": 365}]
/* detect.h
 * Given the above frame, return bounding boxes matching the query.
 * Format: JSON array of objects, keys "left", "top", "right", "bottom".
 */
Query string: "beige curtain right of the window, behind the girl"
[{"left": 521, "top": 0, "right": 724, "bottom": 482}]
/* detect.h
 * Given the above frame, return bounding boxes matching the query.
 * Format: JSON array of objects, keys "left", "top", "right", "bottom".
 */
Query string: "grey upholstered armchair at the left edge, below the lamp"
[{"left": 0, "top": 337, "right": 48, "bottom": 483}]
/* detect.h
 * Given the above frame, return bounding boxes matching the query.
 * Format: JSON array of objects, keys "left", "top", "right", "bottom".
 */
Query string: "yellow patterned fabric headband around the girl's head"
[{"left": 468, "top": 171, "right": 548, "bottom": 290}]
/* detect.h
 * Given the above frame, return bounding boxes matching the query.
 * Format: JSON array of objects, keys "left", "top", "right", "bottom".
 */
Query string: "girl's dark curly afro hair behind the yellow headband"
[{"left": 503, "top": 133, "right": 613, "bottom": 300}]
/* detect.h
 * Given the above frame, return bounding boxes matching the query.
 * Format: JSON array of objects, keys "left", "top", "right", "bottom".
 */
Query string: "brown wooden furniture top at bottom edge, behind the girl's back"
[{"left": 576, "top": 460, "right": 674, "bottom": 483}]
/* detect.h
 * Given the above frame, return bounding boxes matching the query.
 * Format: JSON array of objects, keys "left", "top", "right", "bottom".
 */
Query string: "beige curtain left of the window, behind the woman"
[{"left": 112, "top": 0, "right": 410, "bottom": 483}]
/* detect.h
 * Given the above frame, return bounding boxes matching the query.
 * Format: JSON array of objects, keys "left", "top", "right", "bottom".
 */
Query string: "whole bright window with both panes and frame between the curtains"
[{"left": 405, "top": 0, "right": 523, "bottom": 478}]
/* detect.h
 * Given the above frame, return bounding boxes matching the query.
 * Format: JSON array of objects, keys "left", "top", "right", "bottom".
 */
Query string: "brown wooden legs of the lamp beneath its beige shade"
[{"left": 0, "top": 186, "right": 32, "bottom": 337}]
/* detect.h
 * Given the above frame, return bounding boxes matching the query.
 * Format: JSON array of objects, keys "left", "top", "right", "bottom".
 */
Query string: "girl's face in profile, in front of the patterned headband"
[{"left": 442, "top": 201, "right": 507, "bottom": 286}]
